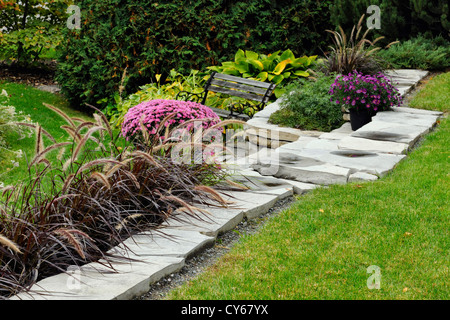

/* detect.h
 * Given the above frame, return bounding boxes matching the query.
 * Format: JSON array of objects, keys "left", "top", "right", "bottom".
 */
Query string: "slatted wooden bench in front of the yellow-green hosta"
[{"left": 176, "top": 72, "right": 276, "bottom": 120}]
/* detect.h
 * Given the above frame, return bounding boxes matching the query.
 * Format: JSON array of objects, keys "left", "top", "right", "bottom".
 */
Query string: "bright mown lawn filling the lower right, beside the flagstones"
[{"left": 167, "top": 74, "right": 450, "bottom": 300}]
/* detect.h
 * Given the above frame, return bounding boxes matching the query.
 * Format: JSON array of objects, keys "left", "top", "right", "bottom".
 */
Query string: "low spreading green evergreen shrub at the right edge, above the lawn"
[{"left": 377, "top": 35, "right": 450, "bottom": 70}]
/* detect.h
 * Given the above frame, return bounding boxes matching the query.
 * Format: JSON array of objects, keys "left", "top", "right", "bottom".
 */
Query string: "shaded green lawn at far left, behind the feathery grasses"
[{"left": 0, "top": 82, "right": 90, "bottom": 186}]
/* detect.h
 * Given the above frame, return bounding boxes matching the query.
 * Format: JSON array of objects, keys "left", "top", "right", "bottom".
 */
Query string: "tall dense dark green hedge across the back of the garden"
[{"left": 57, "top": 0, "right": 331, "bottom": 108}]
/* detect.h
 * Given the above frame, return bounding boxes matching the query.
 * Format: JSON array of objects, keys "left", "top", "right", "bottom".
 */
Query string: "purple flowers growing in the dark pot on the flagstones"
[{"left": 329, "top": 71, "right": 402, "bottom": 113}]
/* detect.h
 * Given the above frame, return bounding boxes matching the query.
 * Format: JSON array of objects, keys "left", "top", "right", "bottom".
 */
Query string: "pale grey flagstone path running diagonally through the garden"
[{"left": 13, "top": 70, "right": 442, "bottom": 300}]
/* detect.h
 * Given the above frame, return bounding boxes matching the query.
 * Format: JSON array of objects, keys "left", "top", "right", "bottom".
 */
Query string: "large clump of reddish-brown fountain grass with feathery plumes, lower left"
[{"left": 0, "top": 106, "right": 236, "bottom": 297}]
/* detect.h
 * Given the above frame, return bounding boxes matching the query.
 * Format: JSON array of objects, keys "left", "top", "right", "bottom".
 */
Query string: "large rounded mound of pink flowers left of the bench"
[{"left": 122, "top": 99, "right": 220, "bottom": 140}]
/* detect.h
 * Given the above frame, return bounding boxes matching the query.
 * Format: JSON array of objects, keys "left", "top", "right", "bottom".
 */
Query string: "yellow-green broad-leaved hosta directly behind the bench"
[{"left": 208, "top": 49, "right": 317, "bottom": 98}]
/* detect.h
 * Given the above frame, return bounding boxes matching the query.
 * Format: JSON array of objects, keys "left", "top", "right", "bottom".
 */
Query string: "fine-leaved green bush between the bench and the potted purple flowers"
[{"left": 269, "top": 75, "right": 343, "bottom": 131}]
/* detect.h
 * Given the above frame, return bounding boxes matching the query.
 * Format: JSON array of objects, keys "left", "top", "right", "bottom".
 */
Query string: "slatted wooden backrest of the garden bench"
[{"left": 203, "top": 72, "right": 276, "bottom": 104}]
